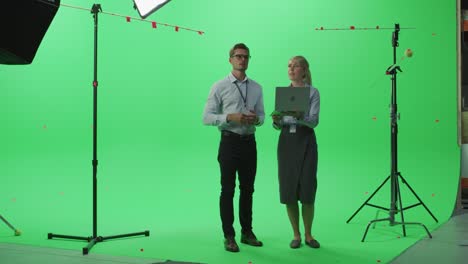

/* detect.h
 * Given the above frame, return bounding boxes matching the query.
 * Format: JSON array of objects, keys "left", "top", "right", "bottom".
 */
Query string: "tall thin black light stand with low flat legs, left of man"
[{"left": 48, "top": 4, "right": 149, "bottom": 255}]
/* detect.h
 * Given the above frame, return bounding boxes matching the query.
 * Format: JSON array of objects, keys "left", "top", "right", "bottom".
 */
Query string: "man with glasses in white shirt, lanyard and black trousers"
[{"left": 203, "top": 43, "right": 265, "bottom": 252}]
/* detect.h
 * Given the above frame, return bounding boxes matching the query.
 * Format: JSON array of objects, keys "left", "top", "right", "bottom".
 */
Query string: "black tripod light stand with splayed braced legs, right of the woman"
[{"left": 346, "top": 24, "right": 439, "bottom": 242}]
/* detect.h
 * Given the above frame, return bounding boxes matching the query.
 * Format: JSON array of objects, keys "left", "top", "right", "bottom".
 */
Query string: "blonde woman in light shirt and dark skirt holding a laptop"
[{"left": 273, "top": 56, "right": 320, "bottom": 248}]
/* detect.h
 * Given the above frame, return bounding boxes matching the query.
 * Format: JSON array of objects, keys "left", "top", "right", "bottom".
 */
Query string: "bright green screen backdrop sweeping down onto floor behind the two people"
[{"left": 0, "top": 0, "right": 460, "bottom": 263}]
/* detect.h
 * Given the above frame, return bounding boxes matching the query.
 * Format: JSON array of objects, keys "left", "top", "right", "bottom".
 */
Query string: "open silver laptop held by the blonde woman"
[{"left": 275, "top": 87, "right": 310, "bottom": 113}]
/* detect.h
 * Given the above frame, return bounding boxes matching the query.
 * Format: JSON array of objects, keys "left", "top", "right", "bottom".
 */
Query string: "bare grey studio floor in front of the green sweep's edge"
[{"left": 0, "top": 209, "right": 468, "bottom": 264}]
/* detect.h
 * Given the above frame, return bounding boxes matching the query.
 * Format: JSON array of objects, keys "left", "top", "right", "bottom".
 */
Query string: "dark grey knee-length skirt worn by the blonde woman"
[{"left": 278, "top": 126, "right": 318, "bottom": 204}]
